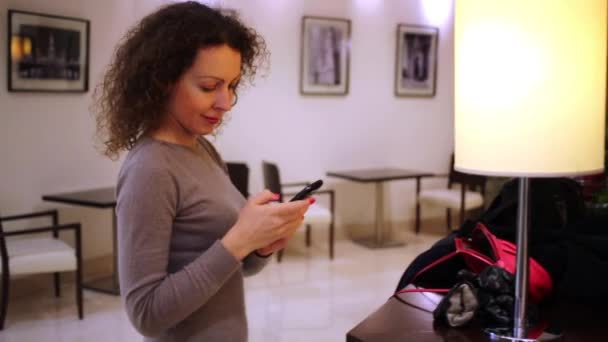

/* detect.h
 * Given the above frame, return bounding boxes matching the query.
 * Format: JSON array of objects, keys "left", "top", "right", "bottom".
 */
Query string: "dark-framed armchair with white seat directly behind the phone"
[{"left": 262, "top": 161, "right": 335, "bottom": 262}]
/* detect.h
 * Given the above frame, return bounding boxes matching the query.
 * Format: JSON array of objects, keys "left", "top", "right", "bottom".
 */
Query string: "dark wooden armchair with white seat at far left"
[{"left": 0, "top": 210, "right": 83, "bottom": 330}]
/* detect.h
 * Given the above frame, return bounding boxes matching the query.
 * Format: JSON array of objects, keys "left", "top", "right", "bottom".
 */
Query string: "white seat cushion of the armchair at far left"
[{"left": 0, "top": 237, "right": 76, "bottom": 276}]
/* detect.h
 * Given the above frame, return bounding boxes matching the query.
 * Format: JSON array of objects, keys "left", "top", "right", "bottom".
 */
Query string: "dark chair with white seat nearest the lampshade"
[{"left": 416, "top": 155, "right": 486, "bottom": 234}]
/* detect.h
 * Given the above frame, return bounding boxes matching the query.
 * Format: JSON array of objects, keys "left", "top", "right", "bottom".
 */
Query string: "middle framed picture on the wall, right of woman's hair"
[{"left": 300, "top": 16, "right": 350, "bottom": 95}]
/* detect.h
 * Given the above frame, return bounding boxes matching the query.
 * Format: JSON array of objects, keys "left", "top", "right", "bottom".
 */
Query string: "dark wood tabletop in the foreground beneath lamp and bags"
[{"left": 346, "top": 293, "right": 608, "bottom": 342}]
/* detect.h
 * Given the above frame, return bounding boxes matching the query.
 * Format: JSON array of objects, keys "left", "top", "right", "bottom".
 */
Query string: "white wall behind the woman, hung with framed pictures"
[{"left": 0, "top": 0, "right": 453, "bottom": 257}]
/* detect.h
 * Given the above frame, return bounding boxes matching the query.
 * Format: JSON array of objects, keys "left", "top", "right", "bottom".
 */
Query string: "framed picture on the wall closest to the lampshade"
[{"left": 395, "top": 24, "right": 439, "bottom": 97}]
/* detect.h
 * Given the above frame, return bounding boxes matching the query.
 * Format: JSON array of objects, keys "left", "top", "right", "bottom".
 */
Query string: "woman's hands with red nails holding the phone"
[{"left": 222, "top": 190, "right": 314, "bottom": 260}]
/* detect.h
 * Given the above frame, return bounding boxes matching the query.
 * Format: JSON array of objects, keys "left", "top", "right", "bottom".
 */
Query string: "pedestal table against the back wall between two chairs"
[{"left": 327, "top": 168, "right": 433, "bottom": 248}]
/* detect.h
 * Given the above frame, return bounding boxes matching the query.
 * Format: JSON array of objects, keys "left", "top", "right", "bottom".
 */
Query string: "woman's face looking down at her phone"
[{"left": 162, "top": 45, "right": 241, "bottom": 139}]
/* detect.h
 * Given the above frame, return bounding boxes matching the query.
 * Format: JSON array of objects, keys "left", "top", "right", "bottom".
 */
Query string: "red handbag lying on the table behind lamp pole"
[{"left": 397, "top": 223, "right": 553, "bottom": 303}]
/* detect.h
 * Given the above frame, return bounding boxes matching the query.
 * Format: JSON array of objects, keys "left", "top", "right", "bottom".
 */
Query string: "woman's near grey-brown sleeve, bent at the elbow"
[{"left": 117, "top": 163, "right": 242, "bottom": 336}]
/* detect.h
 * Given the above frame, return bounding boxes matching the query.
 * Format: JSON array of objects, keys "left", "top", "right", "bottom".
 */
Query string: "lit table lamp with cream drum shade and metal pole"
[{"left": 454, "top": 0, "right": 608, "bottom": 341}]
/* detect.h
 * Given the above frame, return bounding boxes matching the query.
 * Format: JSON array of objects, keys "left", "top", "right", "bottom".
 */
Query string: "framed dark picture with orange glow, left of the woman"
[{"left": 7, "top": 10, "right": 90, "bottom": 92}]
